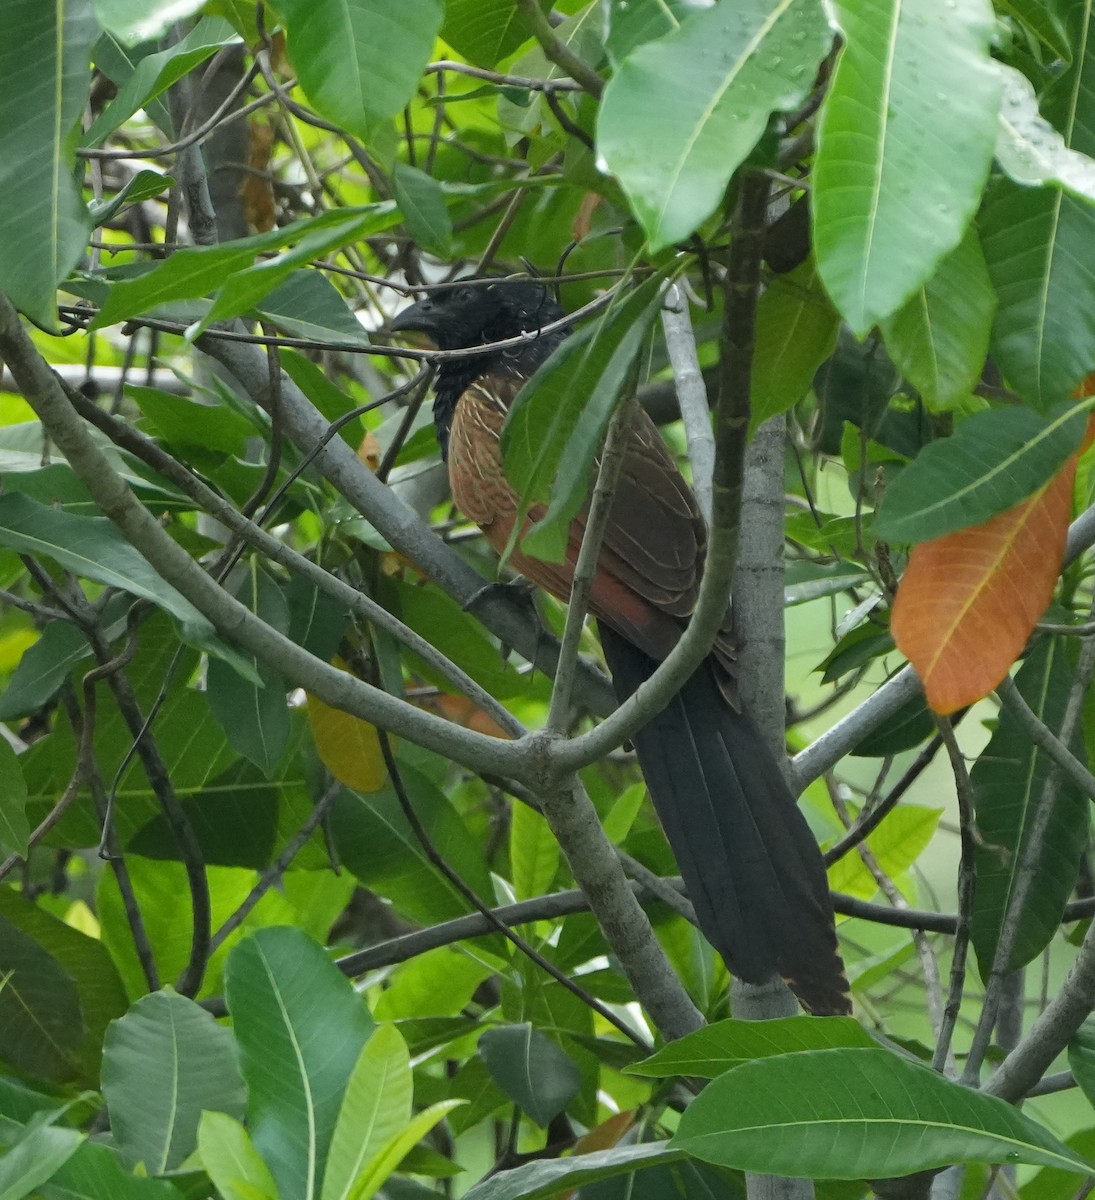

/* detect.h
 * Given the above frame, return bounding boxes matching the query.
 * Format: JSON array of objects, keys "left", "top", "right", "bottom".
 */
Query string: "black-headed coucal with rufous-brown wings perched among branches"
[{"left": 391, "top": 278, "right": 850, "bottom": 1014}]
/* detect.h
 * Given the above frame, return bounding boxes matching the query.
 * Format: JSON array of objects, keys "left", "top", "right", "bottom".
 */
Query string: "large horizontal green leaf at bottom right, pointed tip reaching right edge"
[{"left": 670, "top": 1049, "right": 1095, "bottom": 1180}]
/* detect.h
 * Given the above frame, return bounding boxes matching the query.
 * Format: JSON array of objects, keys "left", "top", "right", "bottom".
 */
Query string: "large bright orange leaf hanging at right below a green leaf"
[{"left": 891, "top": 418, "right": 1095, "bottom": 714}]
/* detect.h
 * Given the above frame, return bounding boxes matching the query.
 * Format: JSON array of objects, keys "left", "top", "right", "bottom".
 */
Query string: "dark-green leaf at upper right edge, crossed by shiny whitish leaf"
[{"left": 981, "top": 0, "right": 1095, "bottom": 410}]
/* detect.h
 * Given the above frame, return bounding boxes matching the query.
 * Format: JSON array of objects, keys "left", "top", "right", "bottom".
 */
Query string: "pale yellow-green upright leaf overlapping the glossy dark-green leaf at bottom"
[{"left": 322, "top": 1025, "right": 414, "bottom": 1200}]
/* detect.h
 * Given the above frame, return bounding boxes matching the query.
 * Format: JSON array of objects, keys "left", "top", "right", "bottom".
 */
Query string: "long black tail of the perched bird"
[{"left": 600, "top": 623, "right": 851, "bottom": 1015}]
